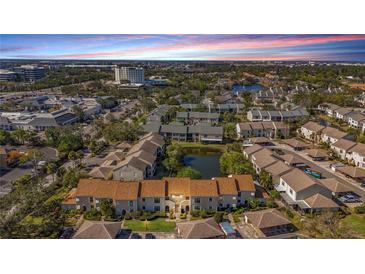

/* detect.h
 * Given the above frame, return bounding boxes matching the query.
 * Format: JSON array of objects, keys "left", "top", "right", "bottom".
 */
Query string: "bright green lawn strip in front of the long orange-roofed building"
[{"left": 124, "top": 218, "right": 176, "bottom": 232}]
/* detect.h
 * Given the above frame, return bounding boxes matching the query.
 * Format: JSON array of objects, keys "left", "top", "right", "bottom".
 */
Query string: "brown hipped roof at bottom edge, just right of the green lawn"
[{"left": 176, "top": 218, "right": 225, "bottom": 239}]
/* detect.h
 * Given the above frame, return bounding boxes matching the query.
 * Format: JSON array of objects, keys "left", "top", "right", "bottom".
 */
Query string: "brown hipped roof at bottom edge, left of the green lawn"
[{"left": 73, "top": 220, "right": 121, "bottom": 239}]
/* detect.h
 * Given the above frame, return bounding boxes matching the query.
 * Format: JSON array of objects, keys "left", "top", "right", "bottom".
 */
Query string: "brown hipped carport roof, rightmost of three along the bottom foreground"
[{"left": 245, "top": 209, "right": 290, "bottom": 229}]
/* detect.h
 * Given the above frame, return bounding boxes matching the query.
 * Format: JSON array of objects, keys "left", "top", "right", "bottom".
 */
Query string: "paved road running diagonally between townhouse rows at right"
[{"left": 274, "top": 142, "right": 365, "bottom": 200}]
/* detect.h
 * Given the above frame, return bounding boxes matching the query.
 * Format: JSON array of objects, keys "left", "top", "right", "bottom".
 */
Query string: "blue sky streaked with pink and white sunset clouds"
[{"left": 0, "top": 34, "right": 365, "bottom": 62}]
